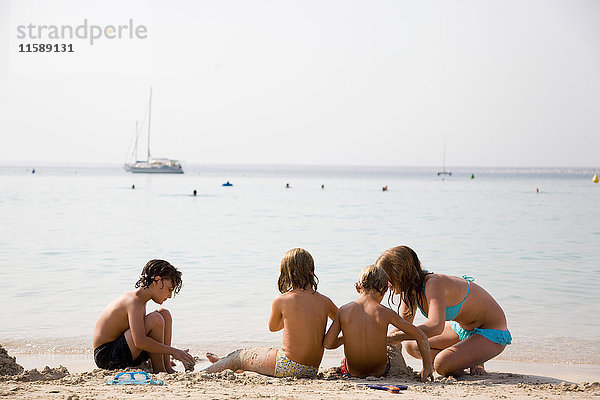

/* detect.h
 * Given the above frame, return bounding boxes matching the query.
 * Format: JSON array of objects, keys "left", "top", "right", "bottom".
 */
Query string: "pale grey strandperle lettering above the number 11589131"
[{"left": 17, "top": 19, "right": 148, "bottom": 46}]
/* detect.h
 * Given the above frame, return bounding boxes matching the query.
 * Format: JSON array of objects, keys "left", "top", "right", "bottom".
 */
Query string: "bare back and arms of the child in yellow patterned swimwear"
[{"left": 269, "top": 289, "right": 337, "bottom": 367}]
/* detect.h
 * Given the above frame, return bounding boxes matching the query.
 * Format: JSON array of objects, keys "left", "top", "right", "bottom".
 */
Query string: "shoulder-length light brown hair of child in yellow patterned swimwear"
[{"left": 277, "top": 248, "right": 319, "bottom": 293}]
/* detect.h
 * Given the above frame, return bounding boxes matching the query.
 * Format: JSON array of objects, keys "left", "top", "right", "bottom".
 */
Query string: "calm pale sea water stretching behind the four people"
[{"left": 0, "top": 165, "right": 600, "bottom": 364}]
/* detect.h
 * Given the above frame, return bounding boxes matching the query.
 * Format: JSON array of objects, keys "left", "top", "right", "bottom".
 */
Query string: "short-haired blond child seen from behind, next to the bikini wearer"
[{"left": 323, "top": 265, "right": 433, "bottom": 381}]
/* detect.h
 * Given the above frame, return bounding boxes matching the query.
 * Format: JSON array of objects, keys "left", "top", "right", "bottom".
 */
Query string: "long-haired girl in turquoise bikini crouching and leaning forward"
[{"left": 377, "top": 246, "right": 512, "bottom": 376}]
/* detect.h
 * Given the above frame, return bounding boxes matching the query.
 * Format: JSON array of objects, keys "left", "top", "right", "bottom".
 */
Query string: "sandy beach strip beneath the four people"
[{"left": 0, "top": 347, "right": 600, "bottom": 400}]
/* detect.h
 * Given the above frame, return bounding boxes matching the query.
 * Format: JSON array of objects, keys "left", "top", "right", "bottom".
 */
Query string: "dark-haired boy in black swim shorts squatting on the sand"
[{"left": 93, "top": 260, "right": 194, "bottom": 373}]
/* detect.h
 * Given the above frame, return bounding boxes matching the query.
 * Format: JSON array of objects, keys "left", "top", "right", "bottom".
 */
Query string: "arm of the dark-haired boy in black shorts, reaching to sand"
[{"left": 126, "top": 301, "right": 195, "bottom": 364}]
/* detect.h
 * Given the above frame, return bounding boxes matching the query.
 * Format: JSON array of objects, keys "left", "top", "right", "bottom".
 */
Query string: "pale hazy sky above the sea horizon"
[{"left": 0, "top": 0, "right": 600, "bottom": 168}]
